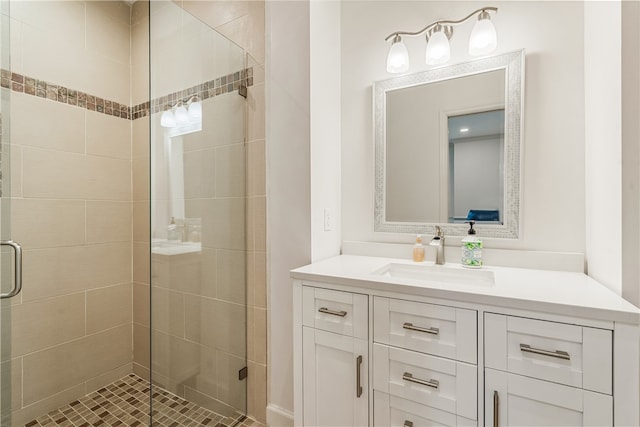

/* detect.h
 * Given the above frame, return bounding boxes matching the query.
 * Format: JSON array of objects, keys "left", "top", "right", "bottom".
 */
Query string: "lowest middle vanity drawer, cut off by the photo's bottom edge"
[{"left": 373, "top": 391, "right": 478, "bottom": 427}]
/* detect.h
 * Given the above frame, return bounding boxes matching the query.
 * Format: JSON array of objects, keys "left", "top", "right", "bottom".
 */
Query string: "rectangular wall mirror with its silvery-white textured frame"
[{"left": 373, "top": 50, "right": 524, "bottom": 239}]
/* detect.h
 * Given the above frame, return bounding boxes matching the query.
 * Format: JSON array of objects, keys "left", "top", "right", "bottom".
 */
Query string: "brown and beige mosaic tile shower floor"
[{"left": 25, "top": 374, "right": 262, "bottom": 427}]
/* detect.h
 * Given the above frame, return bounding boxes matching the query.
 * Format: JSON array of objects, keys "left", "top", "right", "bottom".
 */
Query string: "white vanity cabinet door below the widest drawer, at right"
[{"left": 485, "top": 369, "right": 613, "bottom": 427}]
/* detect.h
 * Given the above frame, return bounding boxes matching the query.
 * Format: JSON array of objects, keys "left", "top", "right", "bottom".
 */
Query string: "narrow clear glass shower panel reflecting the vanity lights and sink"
[{"left": 149, "top": 2, "right": 247, "bottom": 425}]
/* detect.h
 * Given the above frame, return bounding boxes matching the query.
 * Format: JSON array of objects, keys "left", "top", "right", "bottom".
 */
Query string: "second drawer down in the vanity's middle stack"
[{"left": 373, "top": 344, "right": 478, "bottom": 420}]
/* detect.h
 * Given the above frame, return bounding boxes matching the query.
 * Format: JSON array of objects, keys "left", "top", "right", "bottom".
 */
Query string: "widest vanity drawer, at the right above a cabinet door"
[{"left": 484, "top": 313, "right": 613, "bottom": 394}]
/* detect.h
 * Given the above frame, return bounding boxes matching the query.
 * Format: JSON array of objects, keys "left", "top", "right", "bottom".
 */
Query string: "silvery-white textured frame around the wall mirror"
[{"left": 373, "top": 50, "right": 525, "bottom": 239}]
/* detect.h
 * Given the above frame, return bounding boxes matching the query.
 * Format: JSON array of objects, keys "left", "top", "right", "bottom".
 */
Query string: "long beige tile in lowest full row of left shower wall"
[{"left": 23, "top": 325, "right": 132, "bottom": 405}]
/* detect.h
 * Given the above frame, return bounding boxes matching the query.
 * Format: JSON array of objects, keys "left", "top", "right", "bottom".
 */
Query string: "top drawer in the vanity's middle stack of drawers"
[{"left": 373, "top": 297, "right": 478, "bottom": 363}]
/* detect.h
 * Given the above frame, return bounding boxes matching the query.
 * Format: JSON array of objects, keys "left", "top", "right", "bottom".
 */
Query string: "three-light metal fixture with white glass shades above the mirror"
[{"left": 385, "top": 7, "right": 498, "bottom": 74}]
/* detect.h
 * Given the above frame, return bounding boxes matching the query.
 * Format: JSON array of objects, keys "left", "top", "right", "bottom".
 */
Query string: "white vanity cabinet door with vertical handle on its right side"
[{"left": 302, "top": 327, "right": 369, "bottom": 427}]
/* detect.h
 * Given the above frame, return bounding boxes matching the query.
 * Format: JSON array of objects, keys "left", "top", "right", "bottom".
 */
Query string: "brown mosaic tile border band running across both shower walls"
[{"left": 0, "top": 68, "right": 253, "bottom": 120}]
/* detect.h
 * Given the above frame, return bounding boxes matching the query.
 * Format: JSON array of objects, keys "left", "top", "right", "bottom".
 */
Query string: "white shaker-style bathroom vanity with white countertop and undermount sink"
[{"left": 291, "top": 255, "right": 640, "bottom": 427}]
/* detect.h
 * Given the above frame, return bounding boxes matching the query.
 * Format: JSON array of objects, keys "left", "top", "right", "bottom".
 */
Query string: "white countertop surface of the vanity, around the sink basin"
[{"left": 291, "top": 255, "right": 640, "bottom": 324}]
